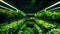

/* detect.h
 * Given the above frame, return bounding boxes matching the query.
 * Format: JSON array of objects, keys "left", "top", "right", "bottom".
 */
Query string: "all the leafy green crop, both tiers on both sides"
[{"left": 0, "top": 9, "right": 60, "bottom": 34}]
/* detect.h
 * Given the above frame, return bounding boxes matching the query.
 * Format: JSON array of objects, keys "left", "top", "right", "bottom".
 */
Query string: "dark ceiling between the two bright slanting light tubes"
[{"left": 0, "top": 0, "right": 59, "bottom": 13}]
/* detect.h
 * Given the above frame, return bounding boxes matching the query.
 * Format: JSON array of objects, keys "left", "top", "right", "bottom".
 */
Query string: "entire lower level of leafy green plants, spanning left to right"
[{"left": 0, "top": 20, "right": 60, "bottom": 34}]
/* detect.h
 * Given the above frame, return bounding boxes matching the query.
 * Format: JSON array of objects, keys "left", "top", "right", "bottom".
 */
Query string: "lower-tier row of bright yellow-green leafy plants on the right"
[{"left": 36, "top": 19, "right": 60, "bottom": 34}]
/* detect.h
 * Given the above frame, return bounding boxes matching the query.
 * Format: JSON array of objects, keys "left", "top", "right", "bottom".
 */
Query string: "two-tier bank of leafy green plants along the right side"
[{"left": 35, "top": 11, "right": 60, "bottom": 34}]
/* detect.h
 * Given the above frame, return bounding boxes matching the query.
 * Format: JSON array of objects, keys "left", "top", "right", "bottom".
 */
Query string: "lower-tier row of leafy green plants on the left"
[{"left": 0, "top": 20, "right": 25, "bottom": 34}]
